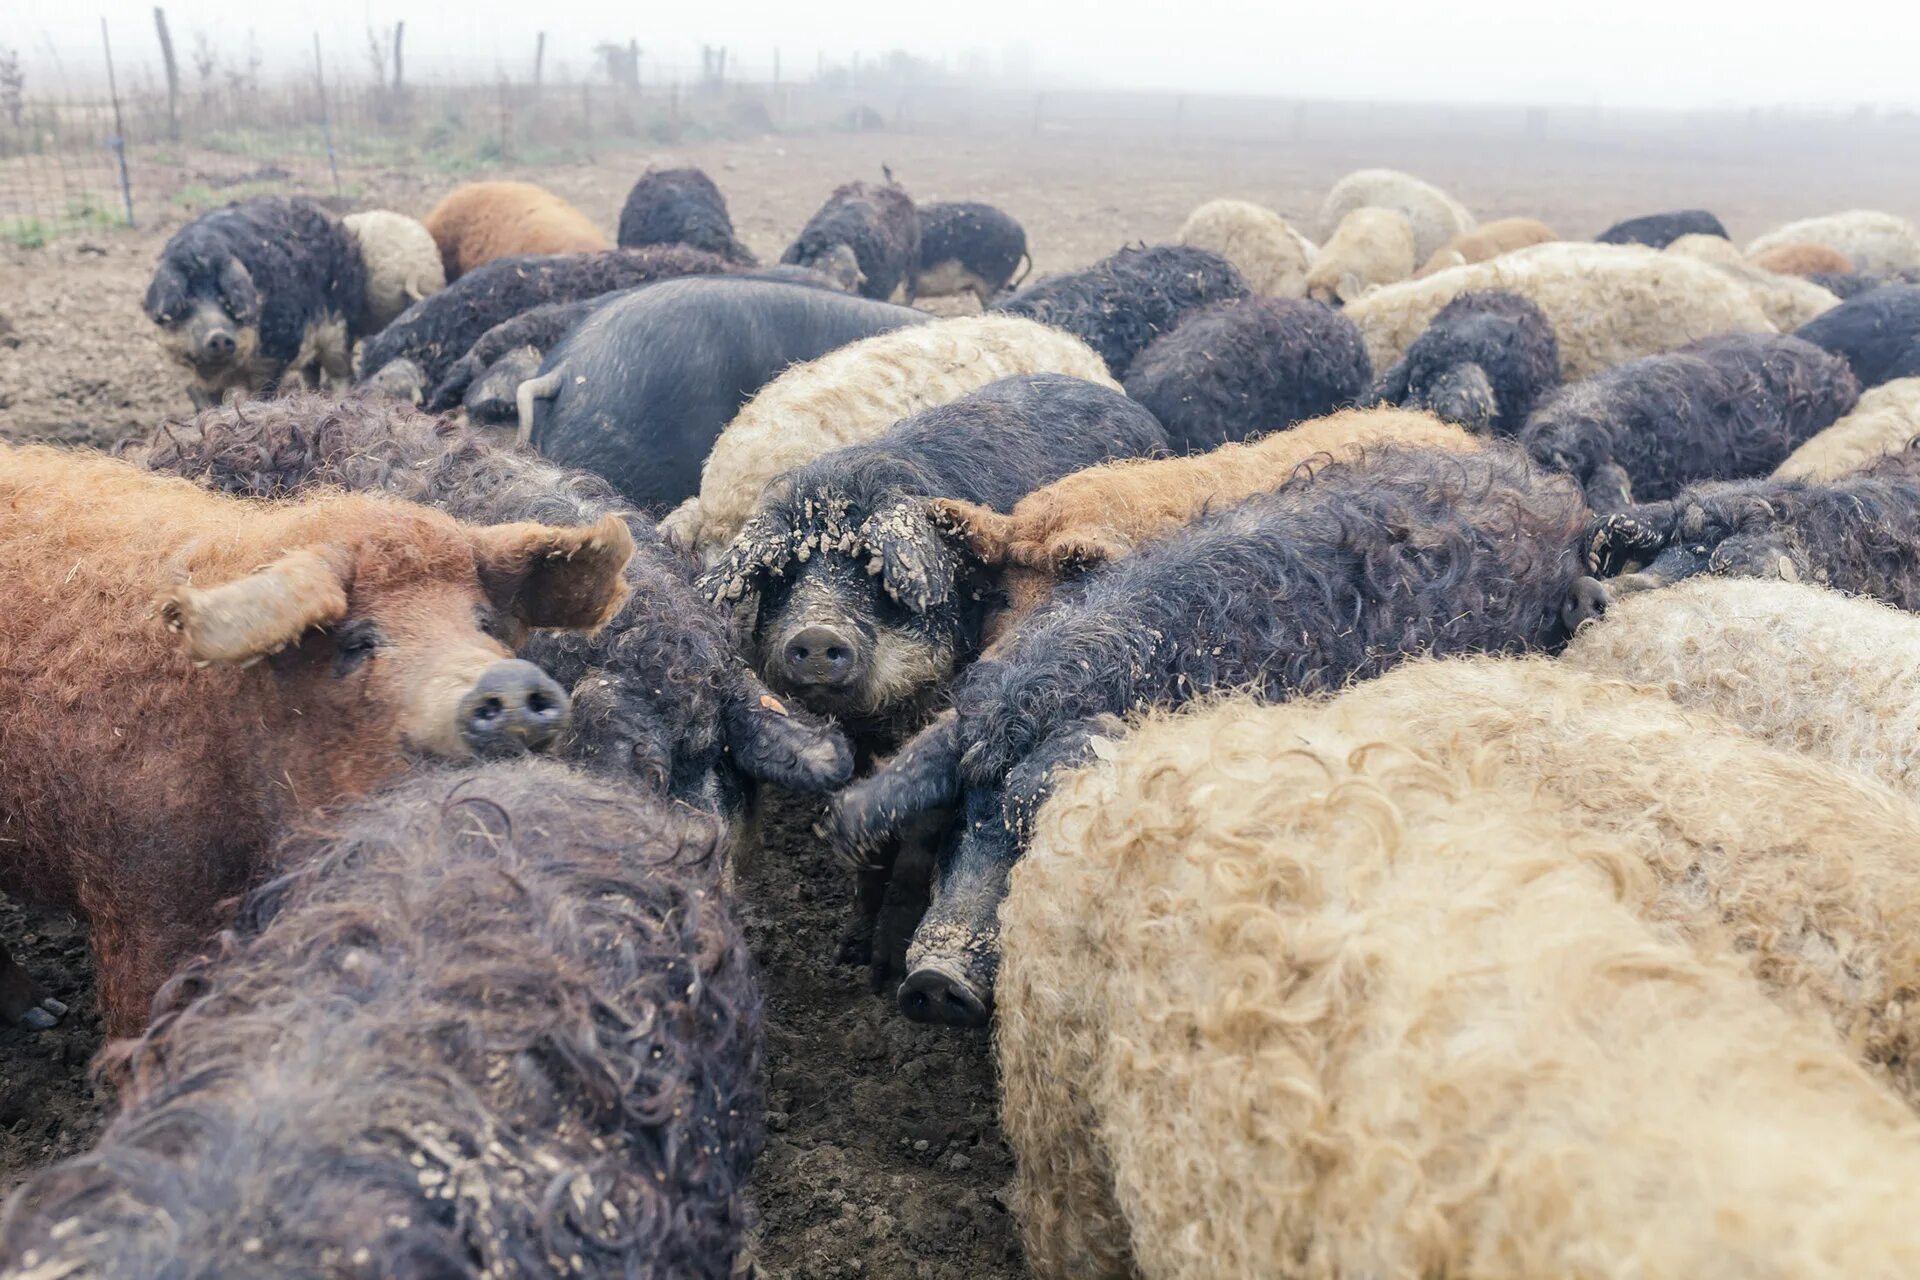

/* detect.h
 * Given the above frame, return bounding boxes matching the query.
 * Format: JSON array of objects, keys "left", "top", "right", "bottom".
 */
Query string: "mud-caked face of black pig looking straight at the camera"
[{"left": 703, "top": 499, "right": 981, "bottom": 731}]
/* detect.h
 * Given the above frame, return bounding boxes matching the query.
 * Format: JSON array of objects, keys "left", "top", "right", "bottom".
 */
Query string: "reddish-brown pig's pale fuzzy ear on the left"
[{"left": 159, "top": 547, "right": 348, "bottom": 666}]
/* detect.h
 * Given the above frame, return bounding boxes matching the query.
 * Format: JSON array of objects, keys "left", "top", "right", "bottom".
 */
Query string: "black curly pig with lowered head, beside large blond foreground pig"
[{"left": 828, "top": 441, "right": 1590, "bottom": 1023}]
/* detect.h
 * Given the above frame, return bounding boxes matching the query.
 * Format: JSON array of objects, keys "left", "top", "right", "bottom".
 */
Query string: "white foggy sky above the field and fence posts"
[{"left": 11, "top": 0, "right": 1920, "bottom": 109}]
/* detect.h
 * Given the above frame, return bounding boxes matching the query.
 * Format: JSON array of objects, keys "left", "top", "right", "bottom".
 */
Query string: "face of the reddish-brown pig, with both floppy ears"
[{"left": 159, "top": 497, "right": 634, "bottom": 771}]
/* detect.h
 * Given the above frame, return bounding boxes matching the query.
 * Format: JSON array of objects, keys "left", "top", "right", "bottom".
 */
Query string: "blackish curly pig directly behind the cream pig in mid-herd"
[{"left": 995, "top": 246, "right": 1248, "bottom": 378}]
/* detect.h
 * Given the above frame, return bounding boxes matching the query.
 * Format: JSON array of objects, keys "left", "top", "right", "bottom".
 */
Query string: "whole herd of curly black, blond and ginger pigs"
[{"left": 0, "top": 169, "right": 1920, "bottom": 1280}]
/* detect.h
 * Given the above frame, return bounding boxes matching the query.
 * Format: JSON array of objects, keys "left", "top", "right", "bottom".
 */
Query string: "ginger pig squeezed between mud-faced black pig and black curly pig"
[{"left": 933, "top": 409, "right": 1478, "bottom": 633}]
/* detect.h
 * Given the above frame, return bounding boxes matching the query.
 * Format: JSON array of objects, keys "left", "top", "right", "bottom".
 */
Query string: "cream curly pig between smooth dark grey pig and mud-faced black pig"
[{"left": 664, "top": 315, "right": 1119, "bottom": 560}]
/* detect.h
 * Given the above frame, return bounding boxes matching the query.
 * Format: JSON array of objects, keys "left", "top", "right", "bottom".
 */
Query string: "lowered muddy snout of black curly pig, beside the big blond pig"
[{"left": 899, "top": 791, "right": 1020, "bottom": 1027}]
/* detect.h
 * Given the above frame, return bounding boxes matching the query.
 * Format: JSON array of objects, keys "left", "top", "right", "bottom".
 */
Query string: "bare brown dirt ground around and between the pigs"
[{"left": 0, "top": 113, "right": 1920, "bottom": 1280}]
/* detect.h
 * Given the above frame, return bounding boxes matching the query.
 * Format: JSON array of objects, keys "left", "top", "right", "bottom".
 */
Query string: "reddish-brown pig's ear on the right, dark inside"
[{"left": 472, "top": 516, "right": 634, "bottom": 631}]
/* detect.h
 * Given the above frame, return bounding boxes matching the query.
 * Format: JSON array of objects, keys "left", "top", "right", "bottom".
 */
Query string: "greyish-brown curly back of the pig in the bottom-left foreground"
[{"left": 0, "top": 762, "right": 764, "bottom": 1280}]
